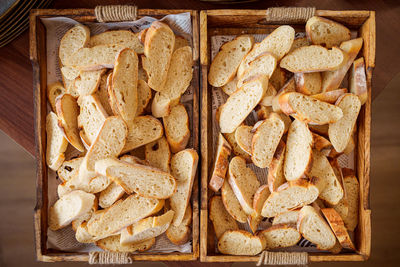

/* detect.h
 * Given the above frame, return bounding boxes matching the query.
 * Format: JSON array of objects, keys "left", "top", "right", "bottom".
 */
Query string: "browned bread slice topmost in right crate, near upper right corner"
[{"left": 306, "top": 16, "right": 350, "bottom": 48}]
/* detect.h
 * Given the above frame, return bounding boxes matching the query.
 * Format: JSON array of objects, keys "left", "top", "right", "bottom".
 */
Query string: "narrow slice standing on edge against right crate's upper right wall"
[{"left": 349, "top": 57, "right": 368, "bottom": 105}]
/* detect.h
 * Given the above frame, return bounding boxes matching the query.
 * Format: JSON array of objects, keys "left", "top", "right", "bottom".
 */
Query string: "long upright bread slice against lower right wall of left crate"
[{"left": 169, "top": 149, "right": 199, "bottom": 226}]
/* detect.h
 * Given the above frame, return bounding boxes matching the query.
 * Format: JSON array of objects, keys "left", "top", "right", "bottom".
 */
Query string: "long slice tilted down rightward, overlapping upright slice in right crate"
[{"left": 279, "top": 92, "right": 343, "bottom": 124}]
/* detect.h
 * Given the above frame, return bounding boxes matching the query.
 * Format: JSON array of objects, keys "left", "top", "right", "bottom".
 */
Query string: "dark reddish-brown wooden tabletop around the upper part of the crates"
[{"left": 0, "top": 0, "right": 400, "bottom": 155}]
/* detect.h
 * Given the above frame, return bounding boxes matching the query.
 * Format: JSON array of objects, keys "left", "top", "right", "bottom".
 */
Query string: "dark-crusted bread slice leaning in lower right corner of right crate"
[{"left": 321, "top": 208, "right": 356, "bottom": 250}]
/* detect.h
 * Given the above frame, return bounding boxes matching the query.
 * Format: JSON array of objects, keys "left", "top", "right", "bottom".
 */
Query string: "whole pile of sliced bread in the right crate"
[{"left": 208, "top": 16, "right": 368, "bottom": 255}]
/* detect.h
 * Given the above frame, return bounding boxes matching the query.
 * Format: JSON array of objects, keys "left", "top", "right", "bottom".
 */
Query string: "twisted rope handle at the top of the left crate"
[{"left": 94, "top": 5, "right": 138, "bottom": 22}]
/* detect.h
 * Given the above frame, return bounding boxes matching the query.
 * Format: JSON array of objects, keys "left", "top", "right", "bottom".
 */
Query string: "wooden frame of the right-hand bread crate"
[{"left": 200, "top": 8, "right": 375, "bottom": 262}]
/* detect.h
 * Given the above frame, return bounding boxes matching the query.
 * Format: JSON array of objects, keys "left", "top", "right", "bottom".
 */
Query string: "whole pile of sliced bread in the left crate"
[{"left": 46, "top": 21, "right": 198, "bottom": 252}]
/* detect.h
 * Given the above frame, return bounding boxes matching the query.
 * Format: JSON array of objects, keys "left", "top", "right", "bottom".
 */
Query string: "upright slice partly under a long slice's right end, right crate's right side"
[{"left": 328, "top": 93, "right": 361, "bottom": 153}]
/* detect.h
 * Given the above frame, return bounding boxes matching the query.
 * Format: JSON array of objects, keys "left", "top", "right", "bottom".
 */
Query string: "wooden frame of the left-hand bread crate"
[{"left": 30, "top": 6, "right": 200, "bottom": 262}]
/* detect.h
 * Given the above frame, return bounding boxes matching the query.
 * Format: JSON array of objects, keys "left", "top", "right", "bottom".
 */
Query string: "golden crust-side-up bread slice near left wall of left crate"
[{"left": 56, "top": 94, "right": 85, "bottom": 152}]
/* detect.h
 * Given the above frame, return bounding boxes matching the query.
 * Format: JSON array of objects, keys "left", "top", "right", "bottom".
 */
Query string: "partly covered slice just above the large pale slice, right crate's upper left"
[{"left": 236, "top": 52, "right": 277, "bottom": 88}]
